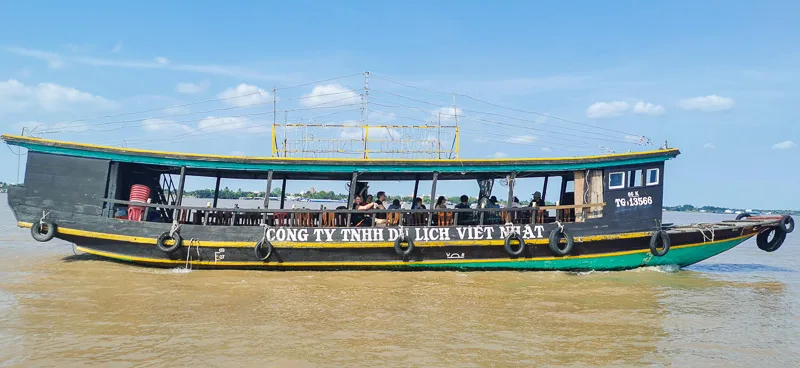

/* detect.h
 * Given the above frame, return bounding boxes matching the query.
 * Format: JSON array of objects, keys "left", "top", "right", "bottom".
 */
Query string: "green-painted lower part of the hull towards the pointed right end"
[{"left": 406, "top": 237, "right": 750, "bottom": 271}]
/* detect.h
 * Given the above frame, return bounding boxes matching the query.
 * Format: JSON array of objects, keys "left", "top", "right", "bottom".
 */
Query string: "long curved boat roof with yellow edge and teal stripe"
[{"left": 1, "top": 134, "right": 680, "bottom": 180}]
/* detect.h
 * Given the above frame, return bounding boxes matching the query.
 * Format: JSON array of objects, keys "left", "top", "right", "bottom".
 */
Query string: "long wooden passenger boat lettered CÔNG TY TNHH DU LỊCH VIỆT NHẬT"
[{"left": 2, "top": 135, "right": 794, "bottom": 271}]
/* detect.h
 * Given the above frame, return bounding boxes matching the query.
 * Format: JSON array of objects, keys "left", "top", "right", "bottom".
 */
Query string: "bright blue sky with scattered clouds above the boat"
[{"left": 0, "top": 1, "right": 800, "bottom": 209}]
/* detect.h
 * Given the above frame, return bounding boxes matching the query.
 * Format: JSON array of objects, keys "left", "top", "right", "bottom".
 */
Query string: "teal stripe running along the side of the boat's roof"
[{"left": 12, "top": 142, "right": 669, "bottom": 172}]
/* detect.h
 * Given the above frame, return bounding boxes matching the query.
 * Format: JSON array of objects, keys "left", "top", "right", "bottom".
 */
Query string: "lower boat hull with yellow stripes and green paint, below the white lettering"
[{"left": 19, "top": 218, "right": 760, "bottom": 271}]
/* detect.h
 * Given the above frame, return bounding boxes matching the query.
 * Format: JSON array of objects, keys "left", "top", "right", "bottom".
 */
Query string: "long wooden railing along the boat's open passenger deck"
[{"left": 103, "top": 198, "right": 605, "bottom": 227}]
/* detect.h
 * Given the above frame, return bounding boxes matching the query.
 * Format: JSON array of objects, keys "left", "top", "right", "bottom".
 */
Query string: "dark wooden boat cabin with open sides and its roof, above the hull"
[{"left": 3, "top": 135, "right": 678, "bottom": 233}]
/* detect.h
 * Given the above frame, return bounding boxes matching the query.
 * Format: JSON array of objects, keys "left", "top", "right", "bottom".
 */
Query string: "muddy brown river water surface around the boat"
[{"left": 0, "top": 194, "right": 800, "bottom": 367}]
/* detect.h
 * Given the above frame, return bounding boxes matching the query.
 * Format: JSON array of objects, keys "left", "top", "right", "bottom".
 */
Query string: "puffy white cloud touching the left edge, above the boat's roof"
[{"left": 0, "top": 79, "right": 118, "bottom": 111}]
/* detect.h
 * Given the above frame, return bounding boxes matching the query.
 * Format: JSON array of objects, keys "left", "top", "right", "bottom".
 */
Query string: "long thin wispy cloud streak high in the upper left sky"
[{"left": 5, "top": 47, "right": 287, "bottom": 81}]
